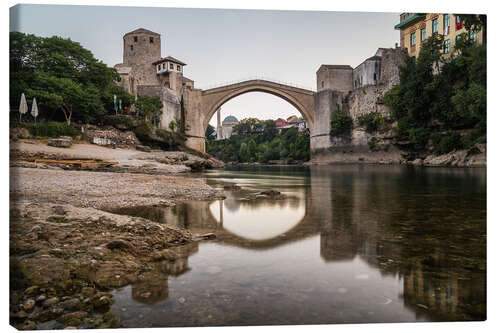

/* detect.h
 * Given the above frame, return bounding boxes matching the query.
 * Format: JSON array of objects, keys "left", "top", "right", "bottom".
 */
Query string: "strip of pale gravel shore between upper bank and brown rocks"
[{"left": 10, "top": 168, "right": 223, "bottom": 209}]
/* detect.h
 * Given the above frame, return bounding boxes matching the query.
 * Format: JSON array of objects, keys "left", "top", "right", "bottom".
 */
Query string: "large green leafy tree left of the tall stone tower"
[{"left": 9, "top": 32, "right": 132, "bottom": 125}]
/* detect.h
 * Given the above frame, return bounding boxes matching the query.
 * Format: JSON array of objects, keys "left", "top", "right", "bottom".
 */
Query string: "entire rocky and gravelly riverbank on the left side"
[{"left": 10, "top": 140, "right": 223, "bottom": 330}]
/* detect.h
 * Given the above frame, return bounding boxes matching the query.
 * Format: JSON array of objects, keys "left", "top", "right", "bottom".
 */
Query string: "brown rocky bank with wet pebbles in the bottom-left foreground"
[{"left": 10, "top": 201, "right": 209, "bottom": 329}]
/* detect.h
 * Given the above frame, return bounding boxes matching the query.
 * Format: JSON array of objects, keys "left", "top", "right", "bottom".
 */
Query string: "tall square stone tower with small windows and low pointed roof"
[{"left": 123, "top": 28, "right": 161, "bottom": 90}]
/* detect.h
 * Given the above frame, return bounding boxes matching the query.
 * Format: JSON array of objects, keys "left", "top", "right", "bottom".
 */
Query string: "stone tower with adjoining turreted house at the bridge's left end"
[{"left": 115, "top": 28, "right": 194, "bottom": 128}]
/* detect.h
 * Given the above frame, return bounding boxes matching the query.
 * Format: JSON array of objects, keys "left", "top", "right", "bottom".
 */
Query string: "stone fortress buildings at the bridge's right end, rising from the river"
[{"left": 311, "top": 46, "right": 408, "bottom": 162}]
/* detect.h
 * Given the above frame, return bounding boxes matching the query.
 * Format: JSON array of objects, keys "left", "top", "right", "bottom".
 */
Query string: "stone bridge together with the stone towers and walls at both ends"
[{"left": 115, "top": 28, "right": 407, "bottom": 156}]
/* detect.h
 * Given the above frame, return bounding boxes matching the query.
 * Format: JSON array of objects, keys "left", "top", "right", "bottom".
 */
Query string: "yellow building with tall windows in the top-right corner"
[{"left": 394, "top": 13, "right": 483, "bottom": 57}]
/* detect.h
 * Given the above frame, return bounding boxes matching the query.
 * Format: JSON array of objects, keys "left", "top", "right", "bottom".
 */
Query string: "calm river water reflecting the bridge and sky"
[{"left": 112, "top": 165, "right": 486, "bottom": 327}]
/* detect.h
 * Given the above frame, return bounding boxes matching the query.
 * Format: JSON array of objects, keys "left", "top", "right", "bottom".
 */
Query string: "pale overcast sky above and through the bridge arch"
[{"left": 10, "top": 5, "right": 399, "bottom": 125}]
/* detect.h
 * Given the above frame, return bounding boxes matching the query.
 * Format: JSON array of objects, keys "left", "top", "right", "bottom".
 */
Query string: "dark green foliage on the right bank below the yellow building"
[{"left": 384, "top": 34, "right": 486, "bottom": 154}]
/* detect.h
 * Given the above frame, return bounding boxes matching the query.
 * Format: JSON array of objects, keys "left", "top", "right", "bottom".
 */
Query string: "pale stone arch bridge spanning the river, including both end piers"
[{"left": 183, "top": 79, "right": 329, "bottom": 152}]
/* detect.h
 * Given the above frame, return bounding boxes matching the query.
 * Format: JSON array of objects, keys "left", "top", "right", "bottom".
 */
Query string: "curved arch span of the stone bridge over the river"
[{"left": 187, "top": 79, "right": 315, "bottom": 151}]
